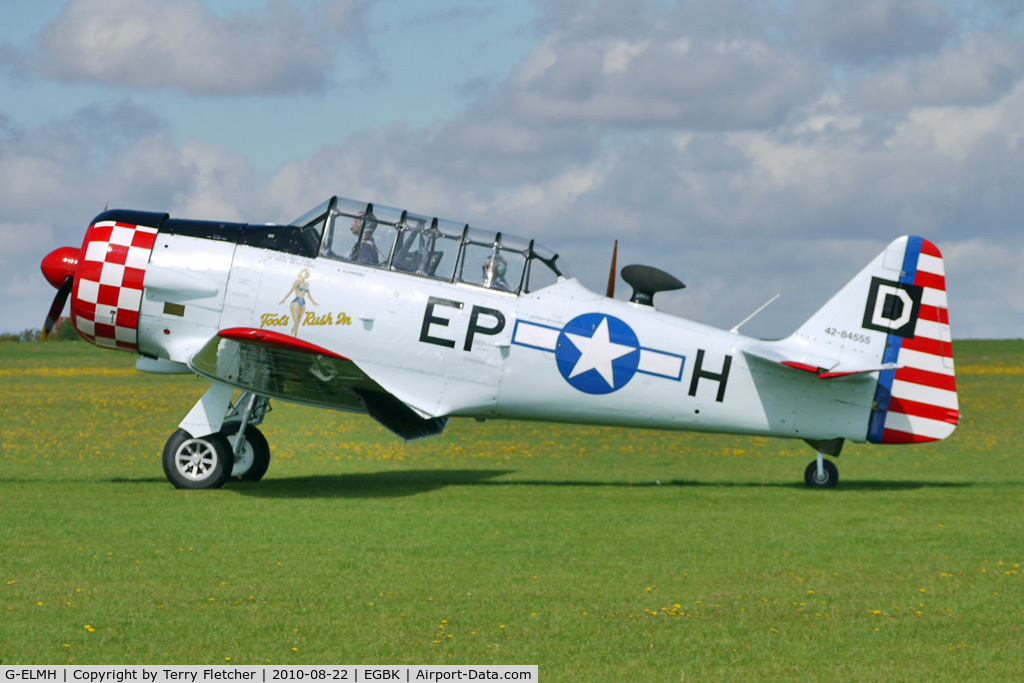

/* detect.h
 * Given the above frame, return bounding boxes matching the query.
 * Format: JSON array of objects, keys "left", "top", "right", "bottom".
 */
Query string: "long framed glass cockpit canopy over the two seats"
[{"left": 290, "top": 197, "right": 572, "bottom": 294}]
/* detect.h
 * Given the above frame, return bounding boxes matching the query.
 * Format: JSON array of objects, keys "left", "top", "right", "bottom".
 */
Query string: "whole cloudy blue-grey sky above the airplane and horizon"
[{"left": 0, "top": 0, "right": 1024, "bottom": 339}]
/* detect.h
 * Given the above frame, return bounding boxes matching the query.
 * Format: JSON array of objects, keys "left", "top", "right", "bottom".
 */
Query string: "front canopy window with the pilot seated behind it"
[{"left": 321, "top": 198, "right": 401, "bottom": 267}]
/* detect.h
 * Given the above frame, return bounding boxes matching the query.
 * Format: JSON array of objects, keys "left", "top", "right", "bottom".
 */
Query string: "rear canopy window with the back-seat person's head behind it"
[{"left": 458, "top": 228, "right": 529, "bottom": 294}]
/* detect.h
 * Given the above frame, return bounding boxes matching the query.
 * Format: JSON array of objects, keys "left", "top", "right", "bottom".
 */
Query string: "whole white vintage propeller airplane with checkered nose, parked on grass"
[{"left": 36, "top": 197, "right": 959, "bottom": 488}]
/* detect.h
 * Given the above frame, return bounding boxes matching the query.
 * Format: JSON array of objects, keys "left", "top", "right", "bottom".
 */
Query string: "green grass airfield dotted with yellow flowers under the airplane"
[{"left": 0, "top": 342, "right": 1024, "bottom": 681}]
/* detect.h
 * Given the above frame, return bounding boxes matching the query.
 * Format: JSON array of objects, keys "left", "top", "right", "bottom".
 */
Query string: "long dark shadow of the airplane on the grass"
[{"left": 201, "top": 469, "right": 975, "bottom": 498}]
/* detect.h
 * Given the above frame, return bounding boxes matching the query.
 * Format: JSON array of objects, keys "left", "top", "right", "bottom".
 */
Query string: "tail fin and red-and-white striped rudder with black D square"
[{"left": 785, "top": 237, "right": 959, "bottom": 443}]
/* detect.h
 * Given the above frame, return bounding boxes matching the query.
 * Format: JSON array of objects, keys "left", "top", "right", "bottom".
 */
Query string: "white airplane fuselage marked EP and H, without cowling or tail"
[{"left": 138, "top": 233, "right": 876, "bottom": 441}]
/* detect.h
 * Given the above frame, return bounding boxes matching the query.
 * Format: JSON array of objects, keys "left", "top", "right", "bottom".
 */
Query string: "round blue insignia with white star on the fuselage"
[{"left": 555, "top": 313, "right": 640, "bottom": 394}]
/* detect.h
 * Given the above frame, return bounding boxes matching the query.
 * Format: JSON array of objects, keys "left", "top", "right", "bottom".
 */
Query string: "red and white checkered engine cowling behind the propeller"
[{"left": 71, "top": 220, "right": 157, "bottom": 351}]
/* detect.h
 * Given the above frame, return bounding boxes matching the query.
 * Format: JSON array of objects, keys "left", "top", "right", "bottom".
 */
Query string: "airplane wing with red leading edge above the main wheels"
[{"left": 188, "top": 328, "right": 447, "bottom": 440}]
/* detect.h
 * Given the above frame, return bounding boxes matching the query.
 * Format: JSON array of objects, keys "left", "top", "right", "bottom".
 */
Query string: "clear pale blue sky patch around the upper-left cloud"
[{"left": 0, "top": 0, "right": 538, "bottom": 174}]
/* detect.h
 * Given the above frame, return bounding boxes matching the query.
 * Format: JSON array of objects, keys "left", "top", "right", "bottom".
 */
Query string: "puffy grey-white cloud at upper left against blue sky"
[{"left": 40, "top": 0, "right": 358, "bottom": 95}]
